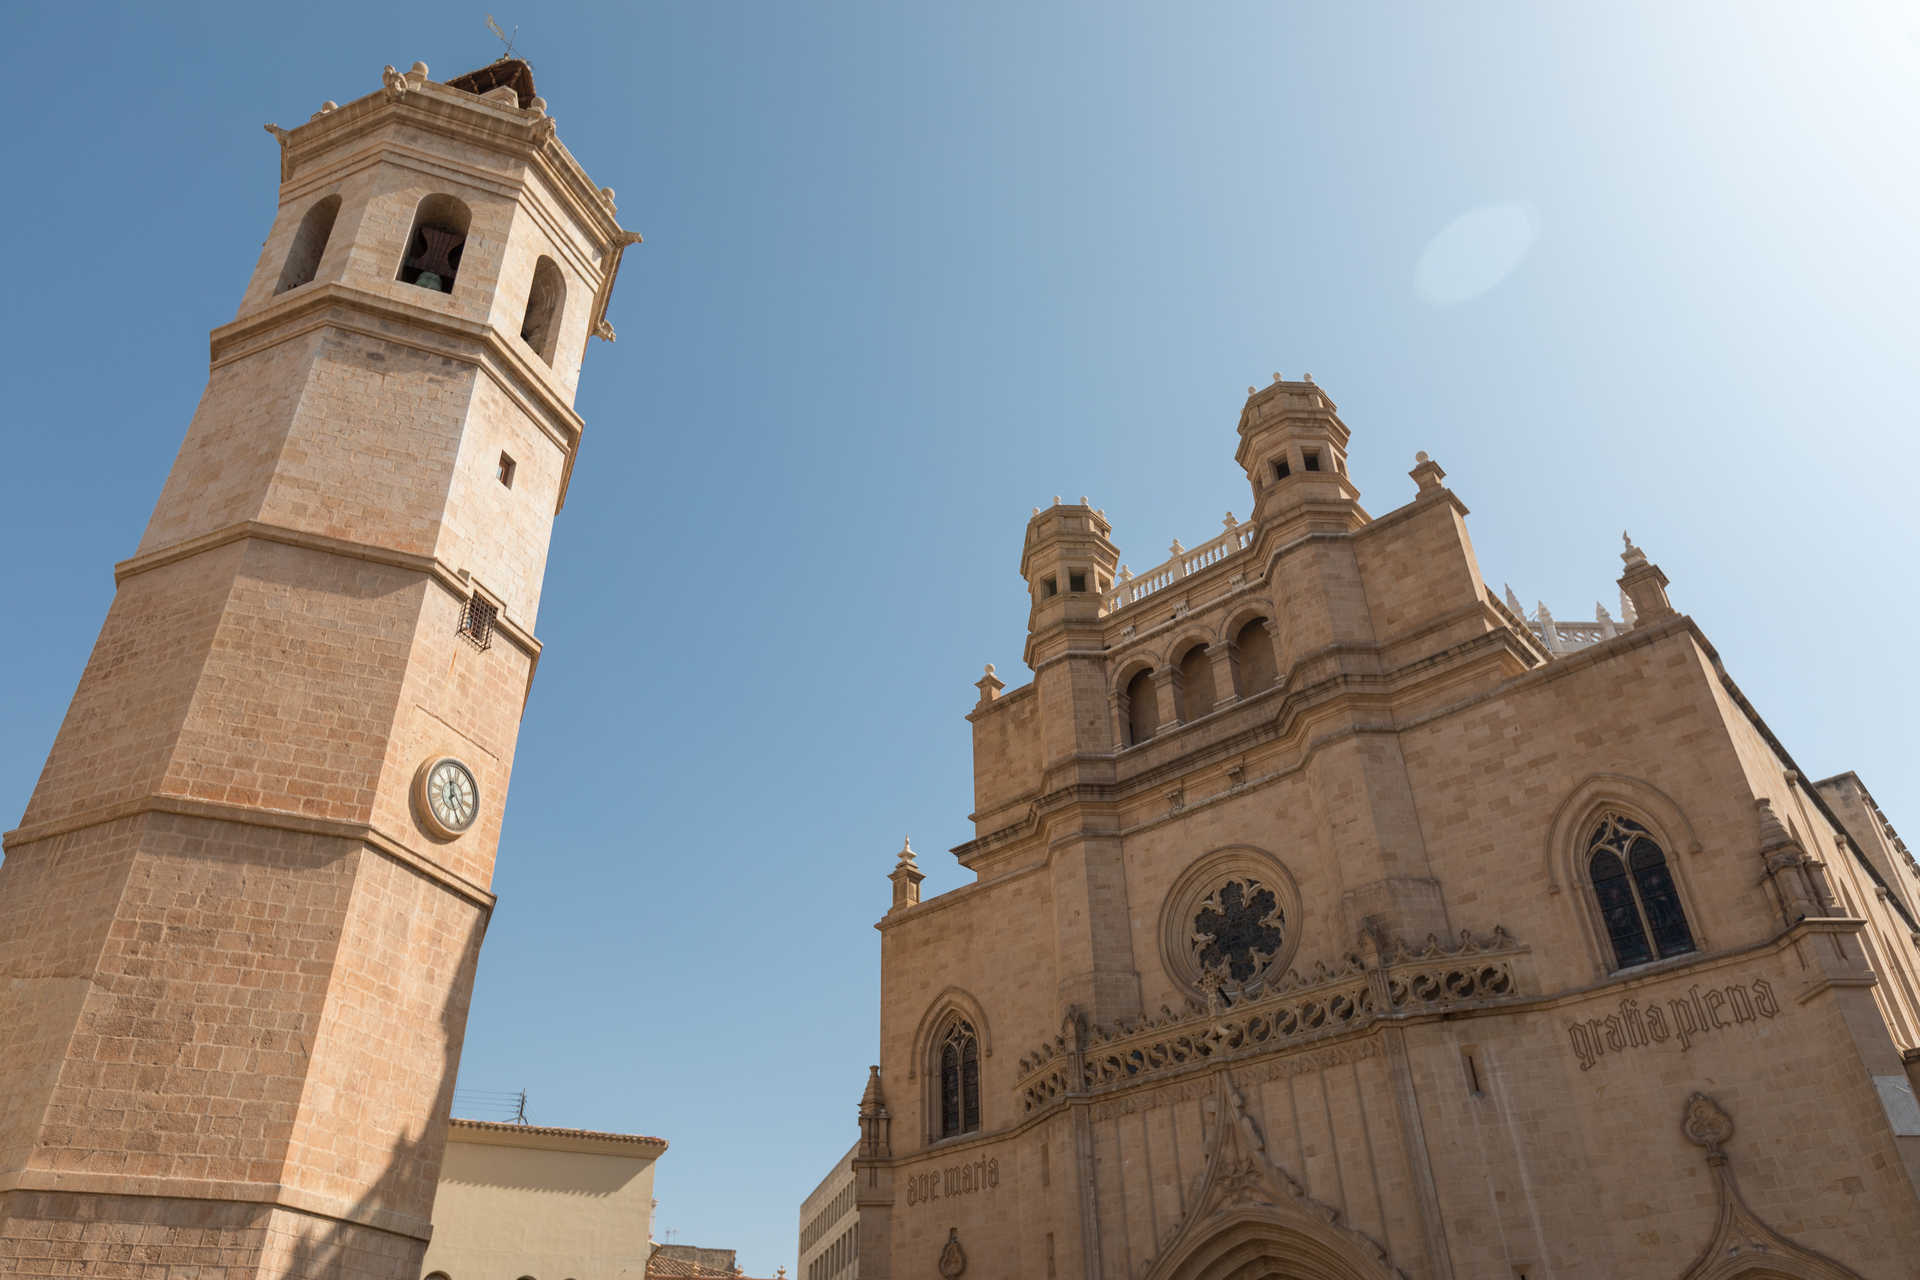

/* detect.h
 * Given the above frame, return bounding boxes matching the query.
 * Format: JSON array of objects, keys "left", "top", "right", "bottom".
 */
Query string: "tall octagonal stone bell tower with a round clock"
[{"left": 0, "top": 59, "right": 637, "bottom": 1280}]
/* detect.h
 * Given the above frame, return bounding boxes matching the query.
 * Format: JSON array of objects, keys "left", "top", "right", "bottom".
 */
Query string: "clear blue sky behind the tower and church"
[{"left": 0, "top": 0, "right": 1920, "bottom": 1274}]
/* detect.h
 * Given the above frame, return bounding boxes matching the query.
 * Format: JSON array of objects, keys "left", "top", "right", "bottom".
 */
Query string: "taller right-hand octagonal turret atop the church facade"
[{"left": 1233, "top": 374, "right": 1359, "bottom": 532}]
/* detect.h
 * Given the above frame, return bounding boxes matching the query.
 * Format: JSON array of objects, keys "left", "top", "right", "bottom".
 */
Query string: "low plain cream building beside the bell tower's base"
[{"left": 420, "top": 1119, "right": 666, "bottom": 1280}]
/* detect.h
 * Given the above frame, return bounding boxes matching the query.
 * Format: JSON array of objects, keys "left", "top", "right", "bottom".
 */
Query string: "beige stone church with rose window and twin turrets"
[{"left": 852, "top": 376, "right": 1920, "bottom": 1280}]
